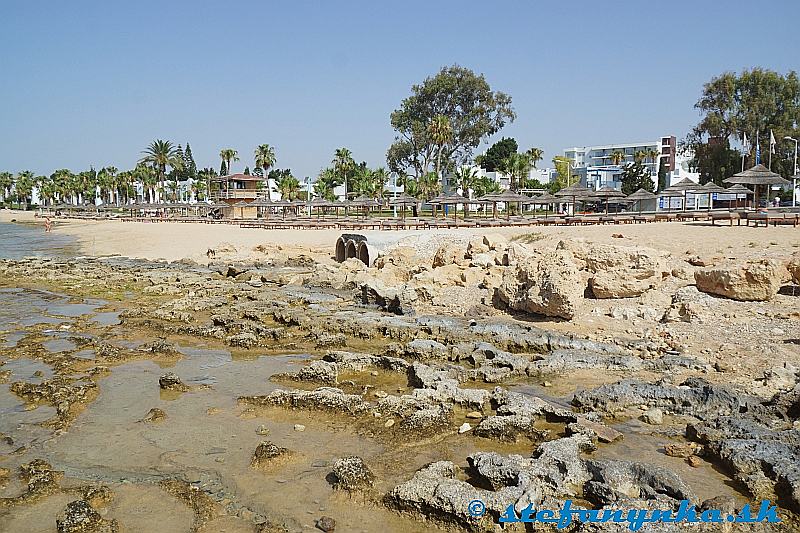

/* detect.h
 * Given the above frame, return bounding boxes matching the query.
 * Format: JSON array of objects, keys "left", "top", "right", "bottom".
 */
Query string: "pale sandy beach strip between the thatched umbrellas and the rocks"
[{"left": 0, "top": 210, "right": 800, "bottom": 263}]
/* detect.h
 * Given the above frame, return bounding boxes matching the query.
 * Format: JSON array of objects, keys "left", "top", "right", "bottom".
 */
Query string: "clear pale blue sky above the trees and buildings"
[{"left": 0, "top": 0, "right": 800, "bottom": 179}]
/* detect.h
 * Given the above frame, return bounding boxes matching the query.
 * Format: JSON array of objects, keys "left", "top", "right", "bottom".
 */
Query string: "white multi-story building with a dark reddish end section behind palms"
[{"left": 564, "top": 136, "right": 677, "bottom": 189}]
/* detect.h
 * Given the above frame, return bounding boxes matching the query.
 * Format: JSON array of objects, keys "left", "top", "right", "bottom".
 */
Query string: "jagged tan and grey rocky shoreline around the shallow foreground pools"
[{"left": 0, "top": 235, "right": 800, "bottom": 531}]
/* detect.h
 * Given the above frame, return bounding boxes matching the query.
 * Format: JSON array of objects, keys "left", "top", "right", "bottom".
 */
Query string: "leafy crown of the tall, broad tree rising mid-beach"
[{"left": 386, "top": 65, "right": 515, "bottom": 177}]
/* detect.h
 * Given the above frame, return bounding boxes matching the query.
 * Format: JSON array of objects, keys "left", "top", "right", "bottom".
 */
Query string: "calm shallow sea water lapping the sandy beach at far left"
[{"left": 0, "top": 222, "right": 75, "bottom": 259}]
